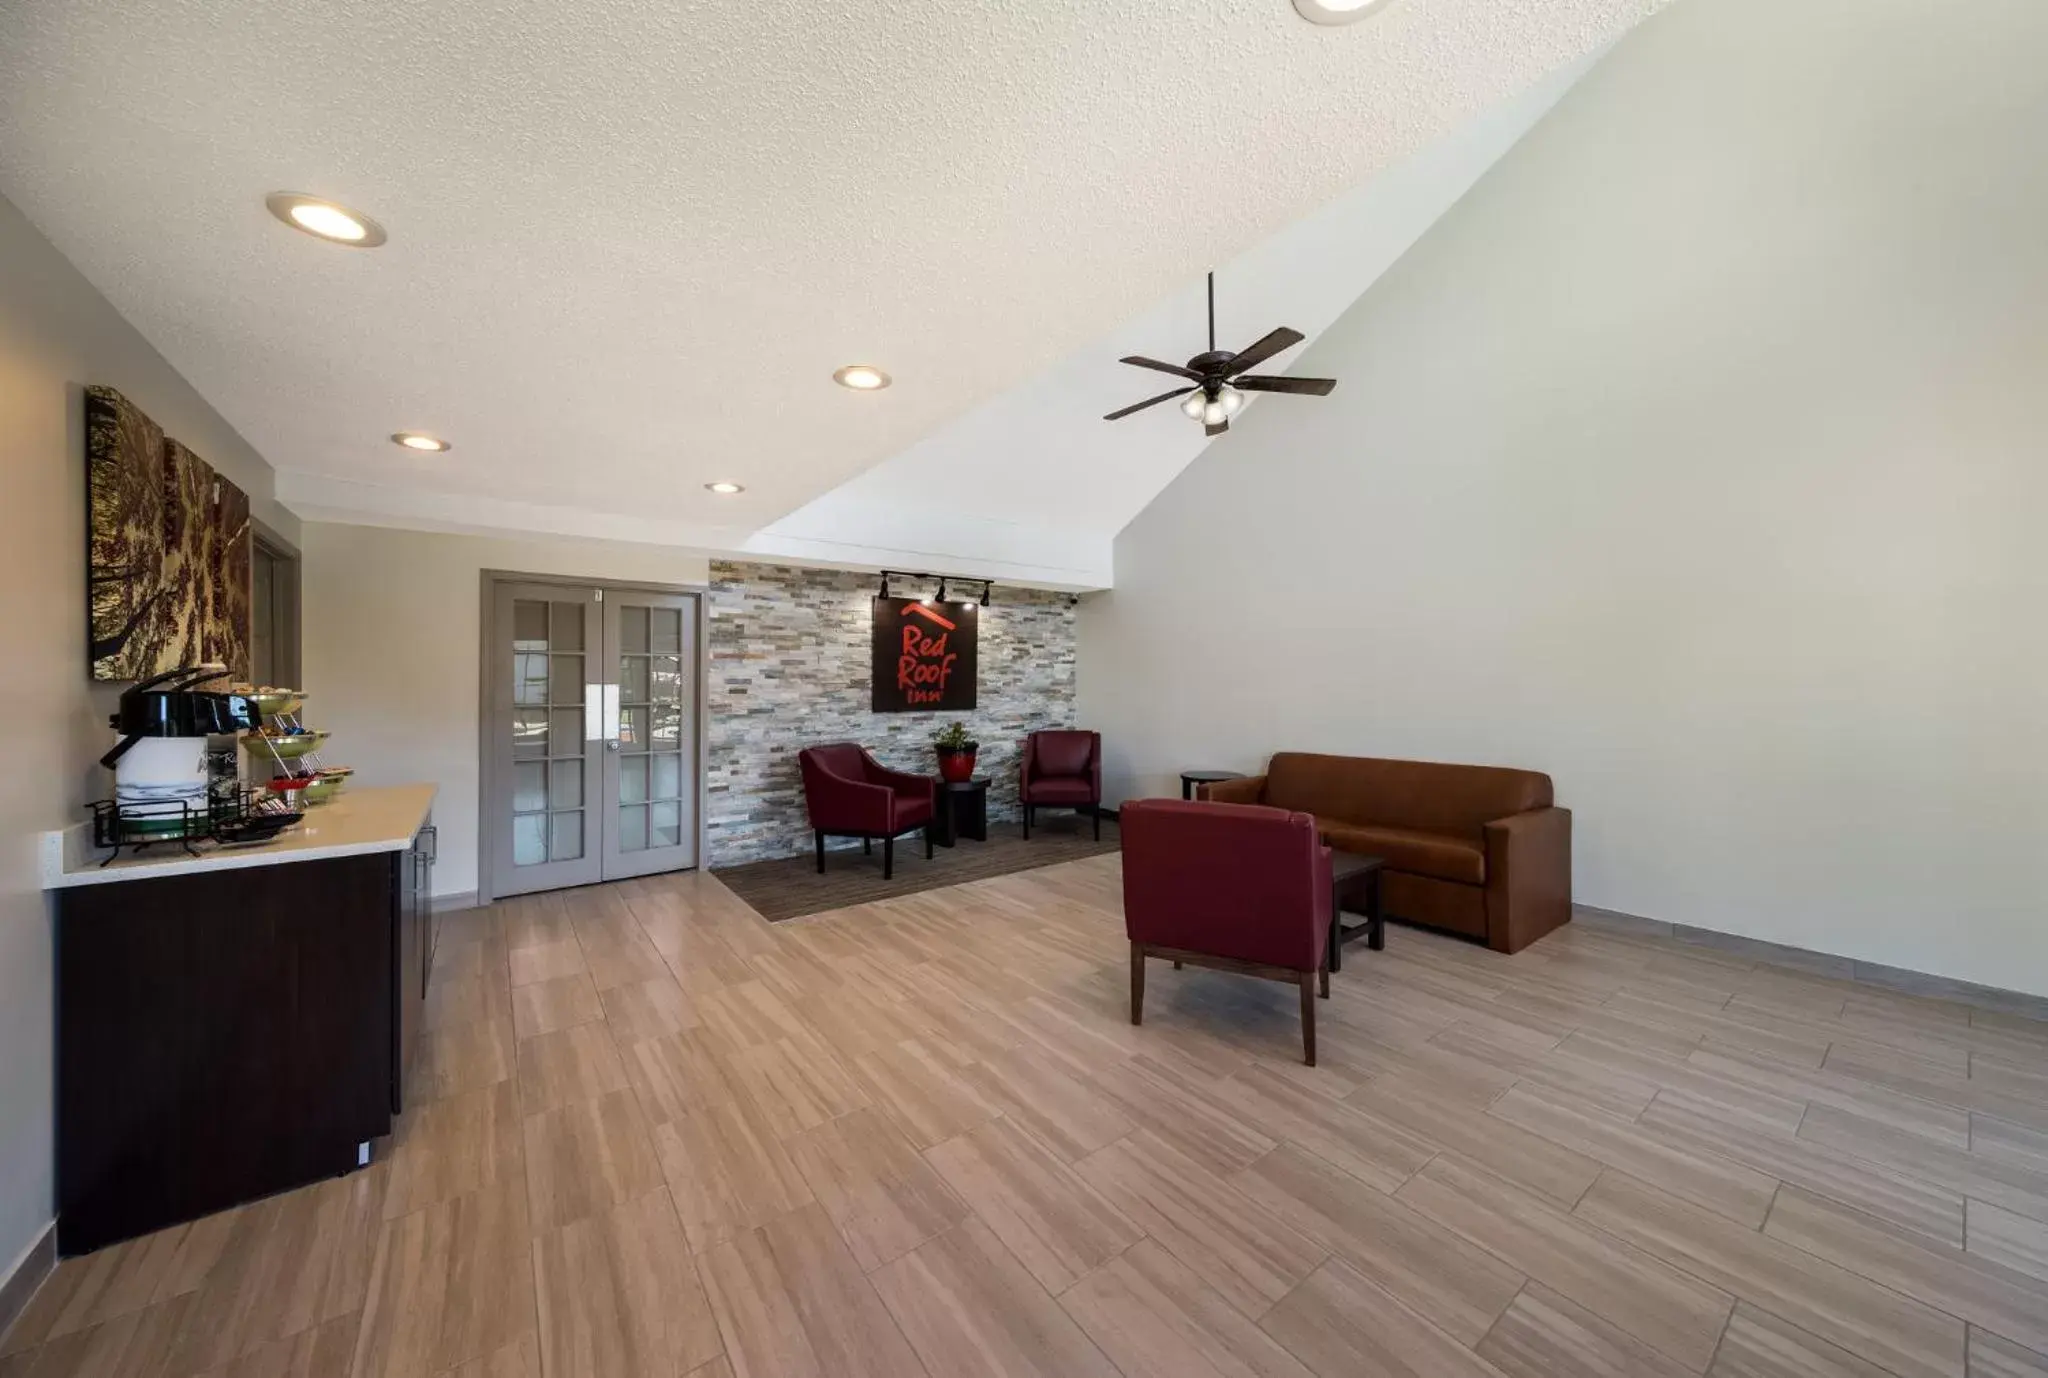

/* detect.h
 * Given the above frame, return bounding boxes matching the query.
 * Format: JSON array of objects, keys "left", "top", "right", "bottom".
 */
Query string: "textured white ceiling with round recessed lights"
[{"left": 0, "top": 0, "right": 1659, "bottom": 573}]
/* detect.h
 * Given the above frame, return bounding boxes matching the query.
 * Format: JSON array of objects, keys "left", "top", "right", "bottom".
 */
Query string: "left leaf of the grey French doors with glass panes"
[{"left": 487, "top": 584, "right": 604, "bottom": 895}]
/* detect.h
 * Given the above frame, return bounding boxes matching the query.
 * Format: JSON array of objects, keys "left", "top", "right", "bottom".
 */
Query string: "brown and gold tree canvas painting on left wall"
[{"left": 86, "top": 387, "right": 252, "bottom": 680}]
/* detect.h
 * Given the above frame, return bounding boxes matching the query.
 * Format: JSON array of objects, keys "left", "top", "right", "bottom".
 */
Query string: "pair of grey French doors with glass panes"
[{"left": 485, "top": 582, "right": 698, "bottom": 897}]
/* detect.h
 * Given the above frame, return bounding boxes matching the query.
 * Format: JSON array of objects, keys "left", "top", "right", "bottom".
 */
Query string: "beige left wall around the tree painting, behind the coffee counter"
[{"left": 0, "top": 199, "right": 299, "bottom": 1280}]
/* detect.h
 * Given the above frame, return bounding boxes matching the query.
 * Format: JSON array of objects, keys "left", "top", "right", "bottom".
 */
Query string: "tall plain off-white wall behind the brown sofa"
[{"left": 1079, "top": 0, "right": 2048, "bottom": 995}]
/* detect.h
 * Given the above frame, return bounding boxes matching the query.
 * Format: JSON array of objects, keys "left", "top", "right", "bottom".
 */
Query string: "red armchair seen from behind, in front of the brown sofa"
[{"left": 1118, "top": 799, "right": 1331, "bottom": 1067}]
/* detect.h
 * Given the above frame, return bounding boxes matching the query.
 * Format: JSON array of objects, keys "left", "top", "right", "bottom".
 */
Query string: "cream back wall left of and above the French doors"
[{"left": 301, "top": 522, "right": 711, "bottom": 895}]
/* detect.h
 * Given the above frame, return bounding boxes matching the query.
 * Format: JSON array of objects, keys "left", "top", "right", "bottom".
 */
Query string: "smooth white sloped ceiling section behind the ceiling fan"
[{"left": 748, "top": 49, "right": 1606, "bottom": 588}]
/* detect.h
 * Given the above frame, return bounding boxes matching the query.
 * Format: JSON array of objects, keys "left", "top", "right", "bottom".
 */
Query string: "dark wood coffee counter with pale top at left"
[{"left": 43, "top": 786, "right": 434, "bottom": 1255}]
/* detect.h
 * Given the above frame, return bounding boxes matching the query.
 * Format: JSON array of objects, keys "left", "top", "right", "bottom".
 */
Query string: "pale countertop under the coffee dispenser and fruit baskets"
[{"left": 41, "top": 784, "right": 434, "bottom": 891}]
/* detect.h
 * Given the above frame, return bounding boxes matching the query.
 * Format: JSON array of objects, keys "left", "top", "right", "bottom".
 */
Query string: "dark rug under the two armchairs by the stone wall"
[{"left": 711, "top": 813, "right": 1118, "bottom": 923}]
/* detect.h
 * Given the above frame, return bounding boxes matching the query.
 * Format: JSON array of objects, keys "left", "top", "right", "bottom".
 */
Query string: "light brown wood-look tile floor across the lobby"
[{"left": 0, "top": 856, "right": 2048, "bottom": 1378}]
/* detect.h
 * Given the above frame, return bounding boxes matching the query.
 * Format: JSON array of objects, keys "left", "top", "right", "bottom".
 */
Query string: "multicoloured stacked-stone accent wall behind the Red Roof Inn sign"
[{"left": 705, "top": 561, "right": 1073, "bottom": 866}]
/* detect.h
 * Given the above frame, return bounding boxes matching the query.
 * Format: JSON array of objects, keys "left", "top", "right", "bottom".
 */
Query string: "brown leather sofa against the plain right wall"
[{"left": 1202, "top": 751, "right": 1571, "bottom": 952}]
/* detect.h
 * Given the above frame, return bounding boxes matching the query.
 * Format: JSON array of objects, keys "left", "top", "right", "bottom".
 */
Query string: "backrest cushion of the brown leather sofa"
[{"left": 1264, "top": 751, "right": 1552, "bottom": 844}]
